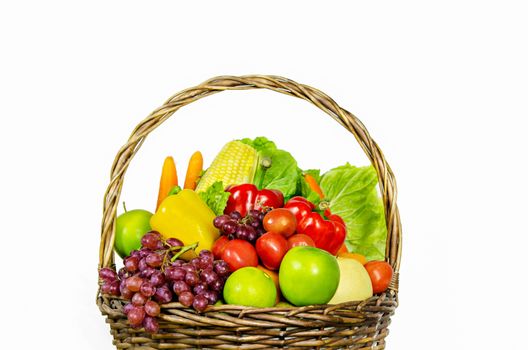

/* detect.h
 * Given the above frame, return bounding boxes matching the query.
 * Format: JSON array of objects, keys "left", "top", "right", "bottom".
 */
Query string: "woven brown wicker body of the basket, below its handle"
[{"left": 98, "top": 293, "right": 398, "bottom": 350}]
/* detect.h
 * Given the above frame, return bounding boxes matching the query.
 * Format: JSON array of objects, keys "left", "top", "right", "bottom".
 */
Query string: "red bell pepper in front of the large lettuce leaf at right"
[{"left": 284, "top": 197, "right": 346, "bottom": 255}]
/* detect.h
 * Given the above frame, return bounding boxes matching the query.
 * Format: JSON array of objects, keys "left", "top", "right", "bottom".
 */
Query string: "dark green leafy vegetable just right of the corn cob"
[{"left": 240, "top": 136, "right": 301, "bottom": 200}]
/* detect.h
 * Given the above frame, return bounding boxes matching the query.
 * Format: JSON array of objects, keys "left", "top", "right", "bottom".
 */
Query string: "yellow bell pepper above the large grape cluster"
[{"left": 150, "top": 189, "right": 220, "bottom": 252}]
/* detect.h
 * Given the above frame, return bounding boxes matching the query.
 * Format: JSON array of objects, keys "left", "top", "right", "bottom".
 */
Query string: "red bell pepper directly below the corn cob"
[{"left": 224, "top": 184, "right": 284, "bottom": 217}]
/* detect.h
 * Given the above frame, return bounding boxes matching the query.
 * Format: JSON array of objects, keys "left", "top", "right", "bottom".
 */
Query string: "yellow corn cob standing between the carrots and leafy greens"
[{"left": 196, "top": 141, "right": 258, "bottom": 192}]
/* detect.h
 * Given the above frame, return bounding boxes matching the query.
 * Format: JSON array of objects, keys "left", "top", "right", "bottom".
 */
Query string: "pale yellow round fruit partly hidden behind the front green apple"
[{"left": 329, "top": 257, "right": 372, "bottom": 304}]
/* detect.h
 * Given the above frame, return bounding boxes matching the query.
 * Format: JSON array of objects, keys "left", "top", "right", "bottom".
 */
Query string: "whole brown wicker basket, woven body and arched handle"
[{"left": 97, "top": 75, "right": 401, "bottom": 349}]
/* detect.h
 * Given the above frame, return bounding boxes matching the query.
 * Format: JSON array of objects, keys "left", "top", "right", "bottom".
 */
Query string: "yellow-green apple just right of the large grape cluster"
[{"left": 224, "top": 267, "right": 277, "bottom": 307}]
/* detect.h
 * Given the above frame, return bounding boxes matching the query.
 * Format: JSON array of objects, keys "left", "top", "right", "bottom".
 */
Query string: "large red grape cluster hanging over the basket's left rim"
[{"left": 99, "top": 231, "right": 230, "bottom": 333}]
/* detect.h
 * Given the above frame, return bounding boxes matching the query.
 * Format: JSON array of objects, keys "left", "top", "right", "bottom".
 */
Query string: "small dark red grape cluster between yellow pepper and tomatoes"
[{"left": 213, "top": 208, "right": 271, "bottom": 244}]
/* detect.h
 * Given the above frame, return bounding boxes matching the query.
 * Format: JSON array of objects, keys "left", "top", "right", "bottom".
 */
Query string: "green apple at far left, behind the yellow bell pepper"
[{"left": 114, "top": 209, "right": 152, "bottom": 258}]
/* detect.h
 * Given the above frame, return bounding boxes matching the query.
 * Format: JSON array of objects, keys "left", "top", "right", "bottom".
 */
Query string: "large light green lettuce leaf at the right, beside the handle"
[{"left": 319, "top": 163, "right": 387, "bottom": 260}]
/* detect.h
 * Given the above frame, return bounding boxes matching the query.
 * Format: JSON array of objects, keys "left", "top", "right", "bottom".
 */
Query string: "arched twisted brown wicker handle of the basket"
[{"left": 99, "top": 75, "right": 401, "bottom": 291}]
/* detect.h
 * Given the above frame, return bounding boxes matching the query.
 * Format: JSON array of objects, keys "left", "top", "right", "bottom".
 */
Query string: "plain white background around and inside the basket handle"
[{"left": 0, "top": 1, "right": 528, "bottom": 349}]
